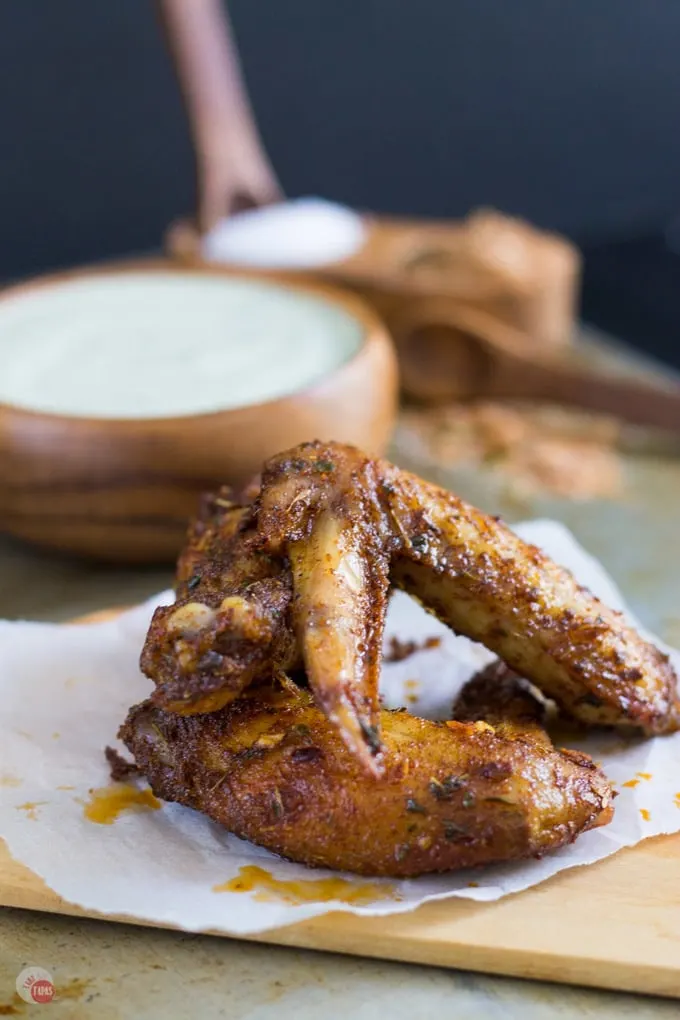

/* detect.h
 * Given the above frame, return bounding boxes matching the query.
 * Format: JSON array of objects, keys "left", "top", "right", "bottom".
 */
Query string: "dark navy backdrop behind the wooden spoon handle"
[{"left": 0, "top": 0, "right": 680, "bottom": 363}]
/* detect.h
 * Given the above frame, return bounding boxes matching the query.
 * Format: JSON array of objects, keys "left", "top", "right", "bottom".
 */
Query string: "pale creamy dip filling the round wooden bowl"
[{"left": 0, "top": 271, "right": 362, "bottom": 418}]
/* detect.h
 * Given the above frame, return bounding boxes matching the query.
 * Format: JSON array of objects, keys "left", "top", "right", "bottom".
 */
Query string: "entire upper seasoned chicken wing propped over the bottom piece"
[{"left": 142, "top": 443, "right": 679, "bottom": 773}]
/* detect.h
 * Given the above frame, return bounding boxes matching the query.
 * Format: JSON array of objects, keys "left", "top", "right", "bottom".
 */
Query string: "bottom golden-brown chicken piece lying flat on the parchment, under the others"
[{"left": 119, "top": 681, "right": 612, "bottom": 877}]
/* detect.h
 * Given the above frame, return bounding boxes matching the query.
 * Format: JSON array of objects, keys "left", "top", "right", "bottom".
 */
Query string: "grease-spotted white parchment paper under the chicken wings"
[{"left": 0, "top": 521, "right": 680, "bottom": 934}]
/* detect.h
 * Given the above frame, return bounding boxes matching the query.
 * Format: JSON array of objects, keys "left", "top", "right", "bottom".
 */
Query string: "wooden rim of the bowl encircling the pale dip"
[{"left": 0, "top": 256, "right": 393, "bottom": 431}]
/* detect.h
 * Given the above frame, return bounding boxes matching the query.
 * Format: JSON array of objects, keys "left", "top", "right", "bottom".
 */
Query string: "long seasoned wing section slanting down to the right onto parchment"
[{"left": 382, "top": 465, "right": 680, "bottom": 734}]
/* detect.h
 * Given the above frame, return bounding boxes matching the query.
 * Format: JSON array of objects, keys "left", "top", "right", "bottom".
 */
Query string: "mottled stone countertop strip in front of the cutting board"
[{"left": 0, "top": 910, "right": 678, "bottom": 1020}]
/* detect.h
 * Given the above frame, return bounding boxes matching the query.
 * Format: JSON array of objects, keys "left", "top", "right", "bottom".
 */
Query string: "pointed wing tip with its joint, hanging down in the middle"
[{"left": 257, "top": 446, "right": 389, "bottom": 772}]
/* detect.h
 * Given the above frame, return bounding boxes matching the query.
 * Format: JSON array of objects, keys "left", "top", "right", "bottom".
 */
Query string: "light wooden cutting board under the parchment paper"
[{"left": 0, "top": 615, "right": 680, "bottom": 998}]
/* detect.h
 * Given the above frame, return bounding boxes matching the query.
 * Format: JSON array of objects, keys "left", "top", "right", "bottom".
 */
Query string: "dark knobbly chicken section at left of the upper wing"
[{"left": 141, "top": 490, "right": 300, "bottom": 714}]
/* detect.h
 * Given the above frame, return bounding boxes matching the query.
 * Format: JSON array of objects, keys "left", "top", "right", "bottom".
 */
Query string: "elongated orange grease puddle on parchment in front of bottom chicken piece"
[{"left": 212, "top": 864, "right": 399, "bottom": 904}]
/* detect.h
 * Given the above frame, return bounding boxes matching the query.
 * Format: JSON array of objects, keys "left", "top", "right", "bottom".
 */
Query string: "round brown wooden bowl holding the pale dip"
[{"left": 0, "top": 260, "right": 398, "bottom": 563}]
